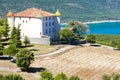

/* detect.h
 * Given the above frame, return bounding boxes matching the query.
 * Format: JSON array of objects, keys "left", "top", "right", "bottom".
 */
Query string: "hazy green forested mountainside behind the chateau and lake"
[{"left": 0, "top": 0, "right": 120, "bottom": 22}]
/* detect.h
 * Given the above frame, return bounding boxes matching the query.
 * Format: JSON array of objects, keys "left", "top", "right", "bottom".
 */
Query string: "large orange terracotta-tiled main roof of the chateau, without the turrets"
[{"left": 14, "top": 8, "right": 55, "bottom": 17}]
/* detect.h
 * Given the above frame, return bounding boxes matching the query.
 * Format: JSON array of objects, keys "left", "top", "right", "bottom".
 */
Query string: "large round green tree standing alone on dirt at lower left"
[{"left": 16, "top": 49, "right": 34, "bottom": 71}]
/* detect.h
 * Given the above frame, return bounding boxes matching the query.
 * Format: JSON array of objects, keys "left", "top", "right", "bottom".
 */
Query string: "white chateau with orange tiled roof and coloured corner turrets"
[{"left": 7, "top": 8, "right": 61, "bottom": 43}]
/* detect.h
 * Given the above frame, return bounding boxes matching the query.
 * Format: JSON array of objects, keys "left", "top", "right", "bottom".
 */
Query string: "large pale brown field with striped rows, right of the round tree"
[{"left": 31, "top": 46, "right": 120, "bottom": 80}]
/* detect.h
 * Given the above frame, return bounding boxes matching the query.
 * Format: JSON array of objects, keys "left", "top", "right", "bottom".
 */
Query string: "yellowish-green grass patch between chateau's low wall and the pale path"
[{"left": 28, "top": 44, "right": 65, "bottom": 54}]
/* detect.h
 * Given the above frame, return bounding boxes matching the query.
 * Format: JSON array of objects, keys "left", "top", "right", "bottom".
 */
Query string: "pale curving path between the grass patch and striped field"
[{"left": 35, "top": 45, "right": 75, "bottom": 58}]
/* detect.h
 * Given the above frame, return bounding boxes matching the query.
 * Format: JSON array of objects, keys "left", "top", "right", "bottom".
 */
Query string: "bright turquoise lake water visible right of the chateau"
[{"left": 61, "top": 22, "right": 120, "bottom": 34}]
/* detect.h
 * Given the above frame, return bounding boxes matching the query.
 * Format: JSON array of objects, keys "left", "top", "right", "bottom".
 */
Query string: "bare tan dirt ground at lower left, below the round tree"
[{"left": 0, "top": 60, "right": 38, "bottom": 80}]
